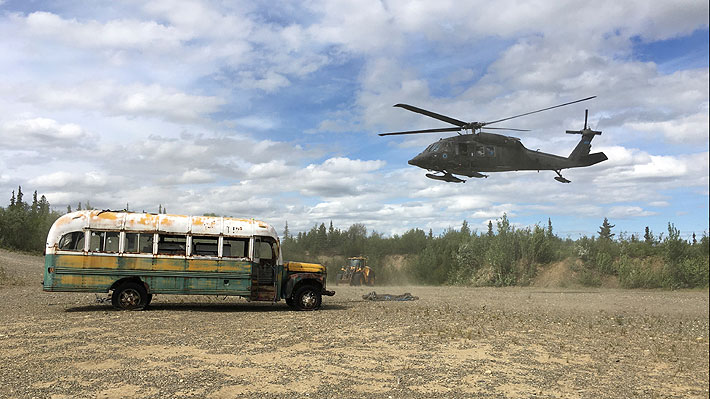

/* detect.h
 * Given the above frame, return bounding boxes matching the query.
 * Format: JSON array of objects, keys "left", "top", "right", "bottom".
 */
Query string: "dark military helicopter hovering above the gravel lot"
[{"left": 379, "top": 96, "right": 608, "bottom": 183}]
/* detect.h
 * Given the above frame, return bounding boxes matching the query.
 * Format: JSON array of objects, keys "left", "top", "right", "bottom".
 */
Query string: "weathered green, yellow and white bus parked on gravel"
[{"left": 43, "top": 210, "right": 335, "bottom": 310}]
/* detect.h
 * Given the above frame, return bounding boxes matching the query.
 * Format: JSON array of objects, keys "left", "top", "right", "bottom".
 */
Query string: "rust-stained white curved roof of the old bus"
[{"left": 47, "top": 210, "right": 278, "bottom": 246}]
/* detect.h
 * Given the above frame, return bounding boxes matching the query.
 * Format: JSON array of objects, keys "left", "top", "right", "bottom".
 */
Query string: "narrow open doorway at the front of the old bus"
[{"left": 251, "top": 237, "right": 278, "bottom": 301}]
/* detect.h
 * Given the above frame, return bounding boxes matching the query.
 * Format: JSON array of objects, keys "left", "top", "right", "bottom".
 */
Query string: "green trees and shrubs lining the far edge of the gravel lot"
[{"left": 0, "top": 187, "right": 710, "bottom": 289}]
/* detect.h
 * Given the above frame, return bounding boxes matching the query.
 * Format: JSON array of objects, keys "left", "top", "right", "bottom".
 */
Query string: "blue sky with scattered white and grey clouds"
[{"left": 0, "top": 0, "right": 710, "bottom": 238}]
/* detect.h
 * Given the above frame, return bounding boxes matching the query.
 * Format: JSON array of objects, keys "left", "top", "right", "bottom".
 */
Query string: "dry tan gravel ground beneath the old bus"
[{"left": 0, "top": 250, "right": 709, "bottom": 398}]
